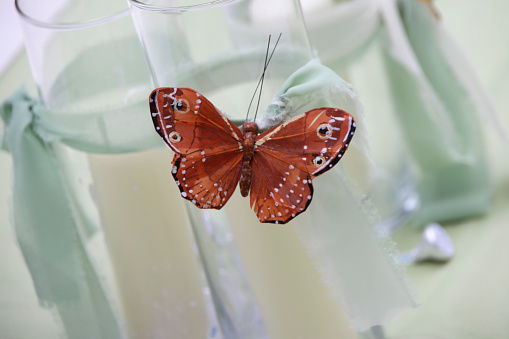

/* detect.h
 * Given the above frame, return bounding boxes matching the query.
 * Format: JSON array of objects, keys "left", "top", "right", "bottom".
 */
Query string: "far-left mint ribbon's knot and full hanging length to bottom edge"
[{"left": 0, "top": 88, "right": 121, "bottom": 338}]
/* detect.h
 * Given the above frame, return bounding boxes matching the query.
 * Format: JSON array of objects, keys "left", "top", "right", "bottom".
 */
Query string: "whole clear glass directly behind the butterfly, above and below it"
[{"left": 130, "top": 0, "right": 364, "bottom": 338}]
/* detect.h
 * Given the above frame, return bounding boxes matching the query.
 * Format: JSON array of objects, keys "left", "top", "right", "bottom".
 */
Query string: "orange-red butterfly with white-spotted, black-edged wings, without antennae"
[{"left": 149, "top": 87, "right": 355, "bottom": 224}]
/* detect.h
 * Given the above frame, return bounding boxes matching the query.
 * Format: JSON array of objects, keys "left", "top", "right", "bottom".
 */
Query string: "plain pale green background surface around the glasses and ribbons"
[{"left": 0, "top": 0, "right": 509, "bottom": 339}]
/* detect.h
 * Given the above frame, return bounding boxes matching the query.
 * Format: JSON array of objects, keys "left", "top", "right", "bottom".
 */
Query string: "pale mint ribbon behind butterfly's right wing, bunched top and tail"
[{"left": 256, "top": 59, "right": 414, "bottom": 331}]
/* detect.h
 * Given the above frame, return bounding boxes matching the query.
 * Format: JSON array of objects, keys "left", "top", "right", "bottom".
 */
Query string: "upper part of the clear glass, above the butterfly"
[{"left": 127, "top": 0, "right": 312, "bottom": 121}]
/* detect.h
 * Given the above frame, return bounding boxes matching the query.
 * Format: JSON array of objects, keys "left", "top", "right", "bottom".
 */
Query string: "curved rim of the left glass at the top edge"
[{"left": 14, "top": 0, "right": 130, "bottom": 30}]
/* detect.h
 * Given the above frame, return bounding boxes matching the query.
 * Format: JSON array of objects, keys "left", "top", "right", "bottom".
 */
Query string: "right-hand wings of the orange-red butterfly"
[{"left": 250, "top": 107, "right": 355, "bottom": 224}]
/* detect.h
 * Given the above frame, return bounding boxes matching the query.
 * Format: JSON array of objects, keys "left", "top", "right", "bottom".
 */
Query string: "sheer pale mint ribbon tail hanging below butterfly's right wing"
[{"left": 292, "top": 164, "right": 415, "bottom": 331}]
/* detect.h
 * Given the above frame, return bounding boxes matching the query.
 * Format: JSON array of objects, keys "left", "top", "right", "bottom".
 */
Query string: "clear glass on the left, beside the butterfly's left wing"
[{"left": 16, "top": 0, "right": 217, "bottom": 338}]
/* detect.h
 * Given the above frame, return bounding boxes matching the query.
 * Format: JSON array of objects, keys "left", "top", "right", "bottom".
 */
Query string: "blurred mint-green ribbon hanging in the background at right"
[{"left": 382, "top": 0, "right": 492, "bottom": 225}]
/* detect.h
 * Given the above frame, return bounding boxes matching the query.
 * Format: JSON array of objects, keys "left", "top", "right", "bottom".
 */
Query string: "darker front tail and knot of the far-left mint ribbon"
[{"left": 0, "top": 91, "right": 84, "bottom": 302}]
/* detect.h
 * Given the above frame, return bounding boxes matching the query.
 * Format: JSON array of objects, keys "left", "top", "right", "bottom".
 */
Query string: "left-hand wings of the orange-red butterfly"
[{"left": 150, "top": 87, "right": 243, "bottom": 209}]
